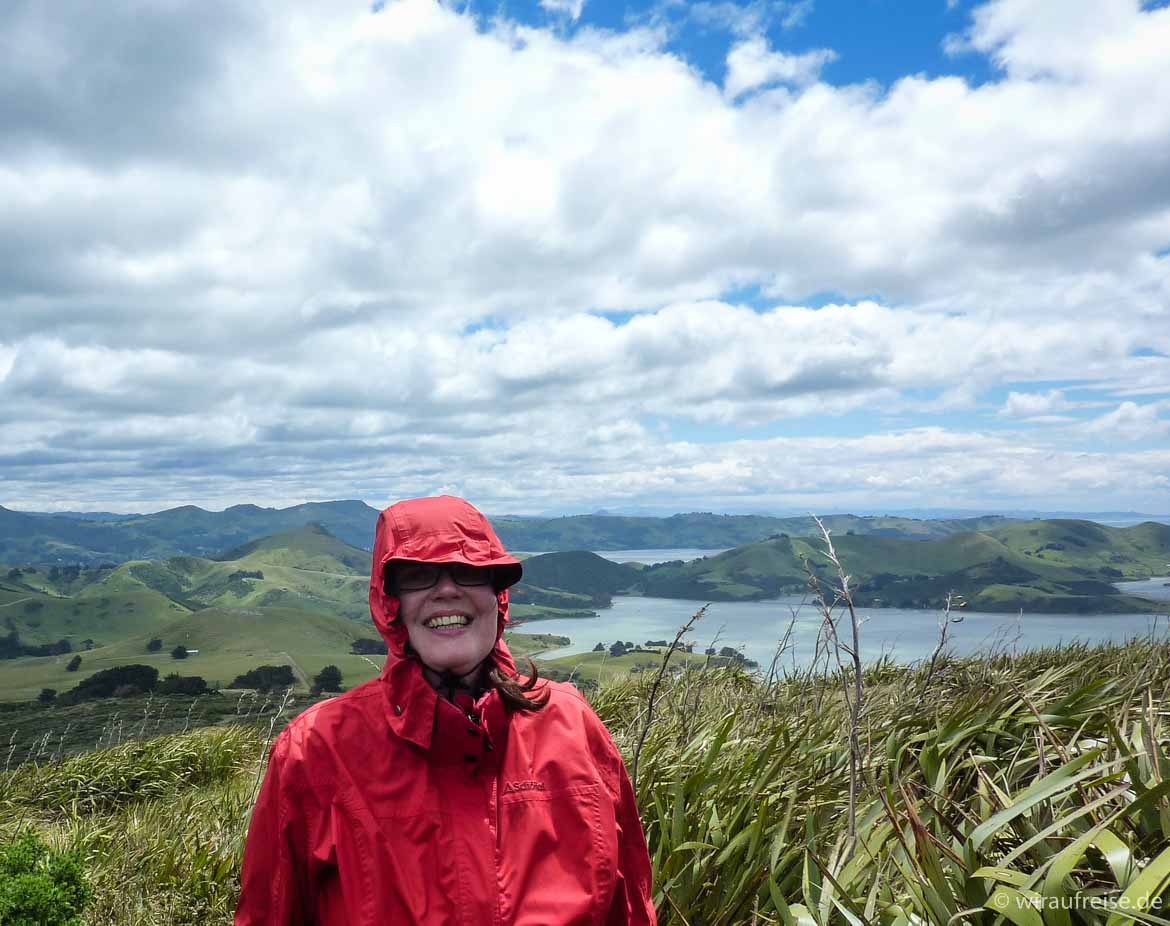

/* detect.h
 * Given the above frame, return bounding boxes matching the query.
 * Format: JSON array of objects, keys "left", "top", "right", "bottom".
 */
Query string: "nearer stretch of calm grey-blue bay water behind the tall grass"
[{"left": 524, "top": 594, "right": 1170, "bottom": 668}]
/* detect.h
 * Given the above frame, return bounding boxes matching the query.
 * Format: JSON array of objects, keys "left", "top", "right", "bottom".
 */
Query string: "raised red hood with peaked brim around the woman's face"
[{"left": 370, "top": 495, "right": 523, "bottom": 678}]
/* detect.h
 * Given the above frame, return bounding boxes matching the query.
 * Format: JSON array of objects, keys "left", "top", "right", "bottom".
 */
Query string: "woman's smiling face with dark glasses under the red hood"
[{"left": 397, "top": 561, "right": 498, "bottom": 675}]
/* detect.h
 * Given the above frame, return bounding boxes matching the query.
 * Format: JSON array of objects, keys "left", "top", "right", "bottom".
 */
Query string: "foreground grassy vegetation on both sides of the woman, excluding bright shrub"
[{"left": 0, "top": 640, "right": 1170, "bottom": 926}]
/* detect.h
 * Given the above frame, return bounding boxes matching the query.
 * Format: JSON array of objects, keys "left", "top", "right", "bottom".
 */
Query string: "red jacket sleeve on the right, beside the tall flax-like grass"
[{"left": 589, "top": 708, "right": 658, "bottom": 926}]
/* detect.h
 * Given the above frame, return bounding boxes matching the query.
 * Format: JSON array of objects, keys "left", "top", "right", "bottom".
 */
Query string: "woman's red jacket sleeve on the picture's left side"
[{"left": 233, "top": 729, "right": 312, "bottom": 926}]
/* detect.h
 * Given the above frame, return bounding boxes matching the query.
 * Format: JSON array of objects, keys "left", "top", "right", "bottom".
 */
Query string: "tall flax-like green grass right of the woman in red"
[{"left": 597, "top": 642, "right": 1170, "bottom": 926}]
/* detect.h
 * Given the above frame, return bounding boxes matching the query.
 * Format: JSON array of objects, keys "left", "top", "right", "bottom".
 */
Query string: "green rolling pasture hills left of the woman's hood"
[{"left": 0, "top": 524, "right": 567, "bottom": 700}]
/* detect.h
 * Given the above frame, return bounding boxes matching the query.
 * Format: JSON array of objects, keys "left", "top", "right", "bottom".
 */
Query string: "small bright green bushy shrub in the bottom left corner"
[{"left": 0, "top": 835, "right": 89, "bottom": 926}]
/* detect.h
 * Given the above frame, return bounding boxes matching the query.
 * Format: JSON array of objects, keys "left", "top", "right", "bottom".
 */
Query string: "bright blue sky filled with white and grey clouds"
[{"left": 0, "top": 0, "right": 1170, "bottom": 513}]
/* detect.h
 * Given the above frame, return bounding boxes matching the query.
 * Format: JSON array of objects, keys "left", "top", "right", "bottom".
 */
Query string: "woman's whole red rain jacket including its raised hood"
[{"left": 235, "top": 496, "right": 655, "bottom": 926}]
